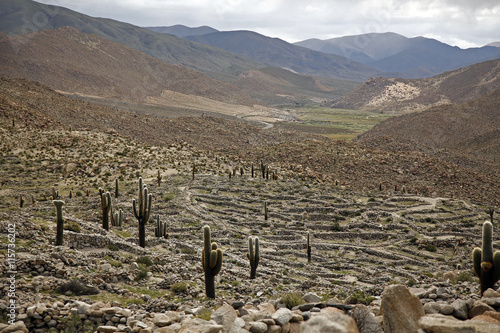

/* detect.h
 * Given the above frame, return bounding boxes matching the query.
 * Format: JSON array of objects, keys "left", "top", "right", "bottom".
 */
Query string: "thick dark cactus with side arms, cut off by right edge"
[{"left": 472, "top": 221, "right": 500, "bottom": 296}]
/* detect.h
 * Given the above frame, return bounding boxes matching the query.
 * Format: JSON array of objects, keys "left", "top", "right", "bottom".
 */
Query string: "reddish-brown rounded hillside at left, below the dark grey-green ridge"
[{"left": 0, "top": 27, "right": 253, "bottom": 104}]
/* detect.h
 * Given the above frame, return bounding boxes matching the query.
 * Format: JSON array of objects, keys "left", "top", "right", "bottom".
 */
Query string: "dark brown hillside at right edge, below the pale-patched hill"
[{"left": 357, "top": 89, "right": 500, "bottom": 176}]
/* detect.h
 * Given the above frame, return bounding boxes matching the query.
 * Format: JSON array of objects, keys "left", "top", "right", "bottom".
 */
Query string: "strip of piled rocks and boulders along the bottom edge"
[{"left": 4, "top": 283, "right": 500, "bottom": 333}]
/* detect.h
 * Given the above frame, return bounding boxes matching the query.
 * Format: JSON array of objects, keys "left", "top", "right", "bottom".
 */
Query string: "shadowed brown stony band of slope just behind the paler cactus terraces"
[{"left": 0, "top": 74, "right": 500, "bottom": 204}]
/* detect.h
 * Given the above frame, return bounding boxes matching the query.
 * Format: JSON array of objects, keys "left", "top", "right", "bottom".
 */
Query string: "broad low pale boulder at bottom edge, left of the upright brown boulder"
[{"left": 300, "top": 313, "right": 359, "bottom": 333}]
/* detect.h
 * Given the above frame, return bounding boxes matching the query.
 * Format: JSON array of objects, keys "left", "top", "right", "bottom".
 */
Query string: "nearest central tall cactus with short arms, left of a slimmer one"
[{"left": 201, "top": 225, "right": 222, "bottom": 298}]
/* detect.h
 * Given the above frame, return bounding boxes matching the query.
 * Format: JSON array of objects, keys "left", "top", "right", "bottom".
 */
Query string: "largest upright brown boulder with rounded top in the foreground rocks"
[{"left": 380, "top": 285, "right": 425, "bottom": 333}]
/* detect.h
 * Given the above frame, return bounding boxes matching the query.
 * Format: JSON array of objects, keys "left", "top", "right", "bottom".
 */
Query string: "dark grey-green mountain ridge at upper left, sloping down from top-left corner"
[{"left": 0, "top": 0, "right": 264, "bottom": 80}]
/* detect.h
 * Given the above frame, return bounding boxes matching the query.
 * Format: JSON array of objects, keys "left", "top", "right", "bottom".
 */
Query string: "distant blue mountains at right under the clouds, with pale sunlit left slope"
[{"left": 295, "top": 32, "right": 500, "bottom": 78}]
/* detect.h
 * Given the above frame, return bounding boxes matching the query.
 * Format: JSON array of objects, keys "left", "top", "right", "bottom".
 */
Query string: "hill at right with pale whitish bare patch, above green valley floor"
[{"left": 328, "top": 60, "right": 500, "bottom": 113}]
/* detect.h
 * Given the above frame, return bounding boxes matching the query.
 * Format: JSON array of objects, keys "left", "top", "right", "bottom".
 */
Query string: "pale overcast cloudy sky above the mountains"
[{"left": 37, "top": 0, "right": 500, "bottom": 48}]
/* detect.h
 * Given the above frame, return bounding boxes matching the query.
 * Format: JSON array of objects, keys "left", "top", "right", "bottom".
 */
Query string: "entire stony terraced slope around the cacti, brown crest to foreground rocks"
[{"left": 0, "top": 75, "right": 500, "bottom": 333}]
